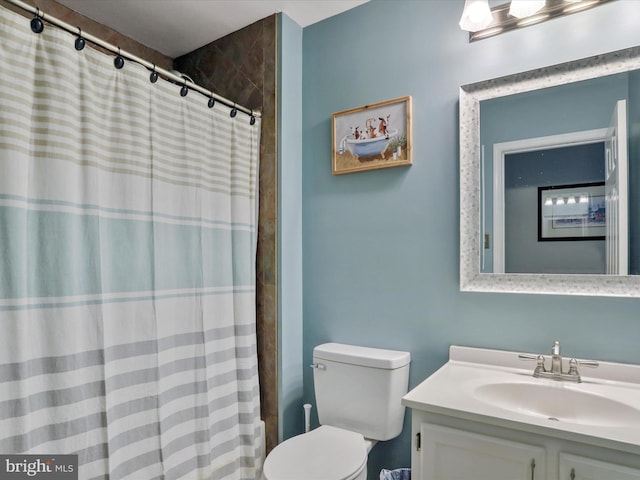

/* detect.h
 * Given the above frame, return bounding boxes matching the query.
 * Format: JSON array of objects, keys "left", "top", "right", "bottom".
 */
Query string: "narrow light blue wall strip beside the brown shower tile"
[{"left": 278, "top": 14, "right": 303, "bottom": 439}]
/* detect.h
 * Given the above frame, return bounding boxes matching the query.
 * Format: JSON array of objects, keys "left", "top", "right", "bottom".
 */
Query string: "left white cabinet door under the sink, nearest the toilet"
[{"left": 417, "top": 423, "right": 544, "bottom": 480}]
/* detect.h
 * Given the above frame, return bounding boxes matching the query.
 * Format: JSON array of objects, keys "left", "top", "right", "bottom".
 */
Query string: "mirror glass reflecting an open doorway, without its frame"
[{"left": 479, "top": 71, "right": 640, "bottom": 275}]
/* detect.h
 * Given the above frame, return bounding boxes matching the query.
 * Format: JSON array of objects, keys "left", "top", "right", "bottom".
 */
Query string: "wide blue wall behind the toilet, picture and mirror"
[{"left": 302, "top": 0, "right": 640, "bottom": 479}]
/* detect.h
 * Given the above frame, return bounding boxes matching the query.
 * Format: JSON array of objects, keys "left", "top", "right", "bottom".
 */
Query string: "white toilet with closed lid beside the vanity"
[{"left": 263, "top": 343, "right": 411, "bottom": 480}]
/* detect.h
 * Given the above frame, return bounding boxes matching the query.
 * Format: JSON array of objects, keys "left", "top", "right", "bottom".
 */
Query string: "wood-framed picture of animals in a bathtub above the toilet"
[{"left": 331, "top": 97, "right": 412, "bottom": 175}]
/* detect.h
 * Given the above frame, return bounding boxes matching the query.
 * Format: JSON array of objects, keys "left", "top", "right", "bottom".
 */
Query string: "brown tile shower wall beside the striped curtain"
[{"left": 174, "top": 15, "right": 278, "bottom": 452}]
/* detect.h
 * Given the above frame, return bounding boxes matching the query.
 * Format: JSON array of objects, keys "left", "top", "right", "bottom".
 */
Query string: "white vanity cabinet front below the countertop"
[{"left": 411, "top": 410, "right": 640, "bottom": 480}]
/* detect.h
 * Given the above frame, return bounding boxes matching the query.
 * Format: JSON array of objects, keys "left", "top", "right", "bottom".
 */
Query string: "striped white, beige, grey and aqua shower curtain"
[{"left": 0, "top": 7, "right": 262, "bottom": 480}]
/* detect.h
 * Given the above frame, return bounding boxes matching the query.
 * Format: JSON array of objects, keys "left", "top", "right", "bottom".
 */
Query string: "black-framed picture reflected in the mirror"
[{"left": 538, "top": 182, "right": 607, "bottom": 242}]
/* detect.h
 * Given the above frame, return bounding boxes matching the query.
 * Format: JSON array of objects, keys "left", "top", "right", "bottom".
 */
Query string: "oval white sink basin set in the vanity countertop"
[{"left": 473, "top": 382, "right": 640, "bottom": 427}]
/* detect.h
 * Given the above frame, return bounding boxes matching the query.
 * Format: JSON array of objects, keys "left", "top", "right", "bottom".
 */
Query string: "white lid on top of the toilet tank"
[{"left": 313, "top": 343, "right": 411, "bottom": 370}]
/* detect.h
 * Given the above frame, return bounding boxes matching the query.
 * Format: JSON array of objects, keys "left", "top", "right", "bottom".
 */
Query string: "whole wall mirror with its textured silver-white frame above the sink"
[{"left": 460, "top": 47, "right": 640, "bottom": 297}]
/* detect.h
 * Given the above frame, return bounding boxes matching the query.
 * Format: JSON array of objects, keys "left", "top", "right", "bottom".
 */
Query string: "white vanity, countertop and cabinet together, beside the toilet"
[{"left": 402, "top": 344, "right": 640, "bottom": 480}]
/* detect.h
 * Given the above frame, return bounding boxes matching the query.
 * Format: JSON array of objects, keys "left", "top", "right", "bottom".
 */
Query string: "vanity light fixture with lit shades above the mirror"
[{"left": 460, "top": 0, "right": 614, "bottom": 42}]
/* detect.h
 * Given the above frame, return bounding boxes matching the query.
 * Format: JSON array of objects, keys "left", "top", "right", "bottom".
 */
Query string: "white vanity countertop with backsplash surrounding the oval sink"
[{"left": 402, "top": 346, "right": 640, "bottom": 454}]
